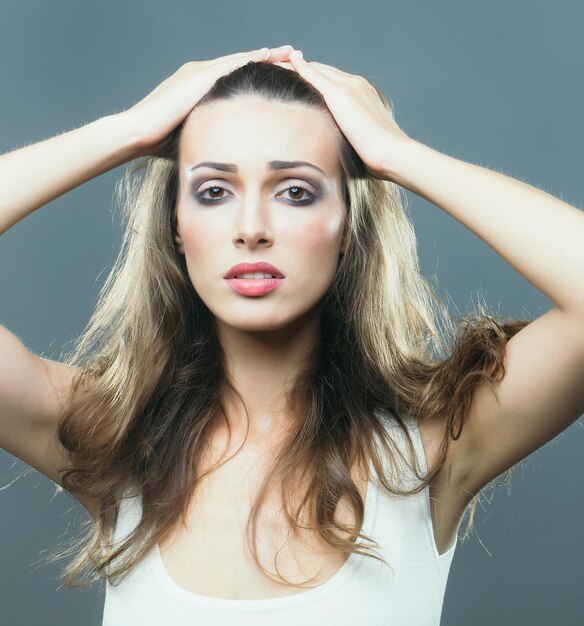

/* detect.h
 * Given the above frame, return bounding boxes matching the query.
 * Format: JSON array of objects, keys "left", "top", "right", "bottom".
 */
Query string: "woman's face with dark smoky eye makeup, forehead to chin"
[{"left": 176, "top": 96, "right": 346, "bottom": 331}]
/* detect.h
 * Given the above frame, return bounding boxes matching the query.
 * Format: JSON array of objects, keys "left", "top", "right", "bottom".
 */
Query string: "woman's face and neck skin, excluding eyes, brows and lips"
[{"left": 176, "top": 96, "right": 346, "bottom": 443}]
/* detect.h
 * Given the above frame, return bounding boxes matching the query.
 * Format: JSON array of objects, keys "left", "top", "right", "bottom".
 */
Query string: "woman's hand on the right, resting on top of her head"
[{"left": 276, "top": 54, "right": 413, "bottom": 180}]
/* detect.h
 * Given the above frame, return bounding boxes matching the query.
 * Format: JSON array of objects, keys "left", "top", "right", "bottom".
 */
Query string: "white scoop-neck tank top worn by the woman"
[{"left": 102, "top": 419, "right": 460, "bottom": 626}]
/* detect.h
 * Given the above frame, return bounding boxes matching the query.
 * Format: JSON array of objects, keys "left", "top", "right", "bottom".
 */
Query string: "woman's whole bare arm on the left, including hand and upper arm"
[{"left": 0, "top": 47, "right": 296, "bottom": 517}]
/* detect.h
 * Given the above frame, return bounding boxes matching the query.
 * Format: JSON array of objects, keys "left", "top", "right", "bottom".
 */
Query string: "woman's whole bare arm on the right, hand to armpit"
[{"left": 281, "top": 54, "right": 584, "bottom": 503}]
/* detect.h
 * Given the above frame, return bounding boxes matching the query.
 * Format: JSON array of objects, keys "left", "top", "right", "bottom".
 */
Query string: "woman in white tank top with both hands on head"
[{"left": 0, "top": 46, "right": 584, "bottom": 626}]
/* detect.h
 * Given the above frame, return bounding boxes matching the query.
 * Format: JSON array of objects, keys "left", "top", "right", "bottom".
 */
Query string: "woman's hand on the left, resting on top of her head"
[{"left": 116, "top": 44, "right": 293, "bottom": 156}]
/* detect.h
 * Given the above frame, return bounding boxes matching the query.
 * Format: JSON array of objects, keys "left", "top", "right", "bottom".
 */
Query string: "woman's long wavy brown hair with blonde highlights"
[{"left": 44, "top": 62, "right": 529, "bottom": 587}]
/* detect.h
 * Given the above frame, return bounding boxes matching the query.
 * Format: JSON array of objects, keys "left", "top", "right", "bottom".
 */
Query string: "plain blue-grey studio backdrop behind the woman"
[{"left": 0, "top": 0, "right": 584, "bottom": 626}]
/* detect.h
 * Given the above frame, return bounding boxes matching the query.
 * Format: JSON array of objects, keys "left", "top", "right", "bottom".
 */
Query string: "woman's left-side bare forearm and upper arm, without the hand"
[{"left": 0, "top": 115, "right": 139, "bottom": 516}]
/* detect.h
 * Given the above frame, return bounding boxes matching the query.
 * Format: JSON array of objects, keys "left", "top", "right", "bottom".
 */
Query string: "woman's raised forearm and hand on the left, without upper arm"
[{"left": 0, "top": 46, "right": 290, "bottom": 234}]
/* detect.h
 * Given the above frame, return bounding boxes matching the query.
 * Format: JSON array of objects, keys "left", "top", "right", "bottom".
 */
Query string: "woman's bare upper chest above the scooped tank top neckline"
[{"left": 159, "top": 436, "right": 368, "bottom": 599}]
